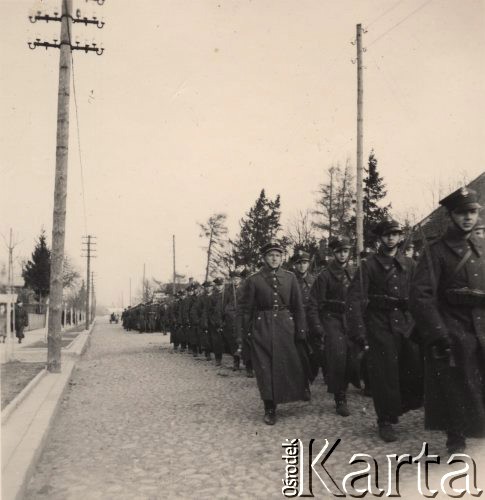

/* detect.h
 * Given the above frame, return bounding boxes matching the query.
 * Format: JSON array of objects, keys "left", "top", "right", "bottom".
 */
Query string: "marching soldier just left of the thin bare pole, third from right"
[{"left": 307, "top": 238, "right": 353, "bottom": 417}]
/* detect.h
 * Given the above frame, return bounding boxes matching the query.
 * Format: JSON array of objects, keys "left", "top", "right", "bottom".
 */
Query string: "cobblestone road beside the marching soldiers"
[{"left": 26, "top": 321, "right": 483, "bottom": 500}]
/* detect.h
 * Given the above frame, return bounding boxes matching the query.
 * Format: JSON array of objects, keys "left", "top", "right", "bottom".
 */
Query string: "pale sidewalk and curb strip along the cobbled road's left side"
[{"left": 1, "top": 321, "right": 96, "bottom": 500}]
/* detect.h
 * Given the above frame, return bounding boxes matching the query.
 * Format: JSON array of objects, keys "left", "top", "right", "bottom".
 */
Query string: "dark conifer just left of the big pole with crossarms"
[{"left": 22, "top": 229, "right": 51, "bottom": 302}]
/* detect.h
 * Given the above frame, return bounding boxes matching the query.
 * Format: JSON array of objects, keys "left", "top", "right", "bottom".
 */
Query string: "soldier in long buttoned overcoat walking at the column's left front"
[{"left": 244, "top": 243, "right": 306, "bottom": 425}]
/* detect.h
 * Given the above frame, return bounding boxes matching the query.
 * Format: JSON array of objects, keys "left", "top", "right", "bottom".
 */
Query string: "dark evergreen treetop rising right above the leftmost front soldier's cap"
[{"left": 233, "top": 189, "right": 281, "bottom": 270}]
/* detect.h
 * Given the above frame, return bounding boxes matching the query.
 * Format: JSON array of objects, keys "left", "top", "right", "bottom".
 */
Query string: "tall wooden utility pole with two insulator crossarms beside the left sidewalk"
[{"left": 28, "top": 0, "right": 104, "bottom": 373}]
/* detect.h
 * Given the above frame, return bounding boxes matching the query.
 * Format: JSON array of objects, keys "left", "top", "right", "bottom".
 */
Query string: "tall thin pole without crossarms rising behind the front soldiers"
[{"left": 355, "top": 24, "right": 364, "bottom": 263}]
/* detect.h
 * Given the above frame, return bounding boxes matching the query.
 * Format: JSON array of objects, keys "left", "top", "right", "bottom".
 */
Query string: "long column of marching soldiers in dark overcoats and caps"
[{"left": 121, "top": 188, "right": 485, "bottom": 453}]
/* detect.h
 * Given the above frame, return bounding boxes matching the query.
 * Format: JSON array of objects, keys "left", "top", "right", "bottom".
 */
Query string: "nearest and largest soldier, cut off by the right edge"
[{"left": 411, "top": 188, "right": 485, "bottom": 453}]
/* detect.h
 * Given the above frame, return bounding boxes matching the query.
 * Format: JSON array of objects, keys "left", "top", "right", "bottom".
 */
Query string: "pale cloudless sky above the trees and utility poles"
[{"left": 0, "top": 0, "right": 485, "bottom": 306}]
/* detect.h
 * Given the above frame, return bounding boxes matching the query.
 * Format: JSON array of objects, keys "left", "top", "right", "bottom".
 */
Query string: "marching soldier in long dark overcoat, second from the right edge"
[{"left": 347, "top": 220, "right": 422, "bottom": 442}]
